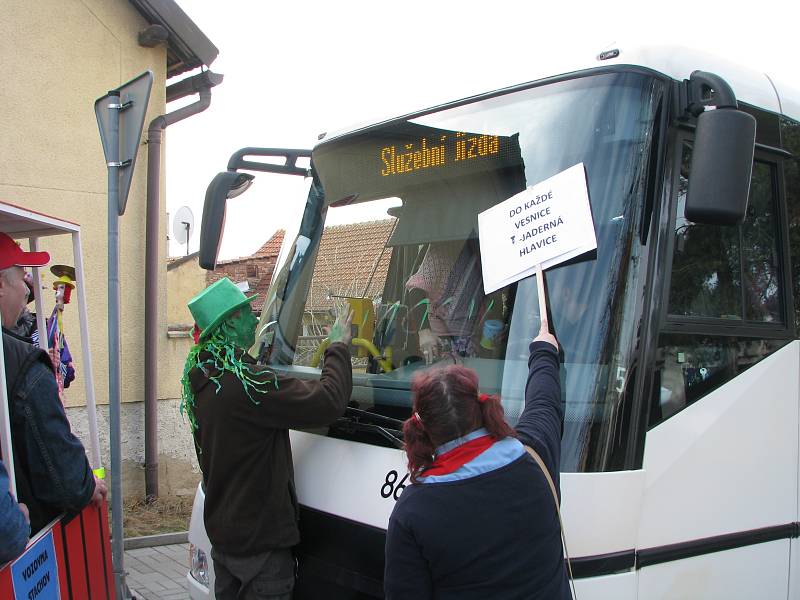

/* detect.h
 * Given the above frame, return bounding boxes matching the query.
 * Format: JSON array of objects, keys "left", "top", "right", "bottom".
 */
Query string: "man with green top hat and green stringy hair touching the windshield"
[{"left": 186, "top": 278, "right": 353, "bottom": 600}]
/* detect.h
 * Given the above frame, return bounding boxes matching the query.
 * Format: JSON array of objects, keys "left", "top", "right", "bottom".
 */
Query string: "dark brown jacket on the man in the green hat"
[{"left": 189, "top": 343, "right": 353, "bottom": 556}]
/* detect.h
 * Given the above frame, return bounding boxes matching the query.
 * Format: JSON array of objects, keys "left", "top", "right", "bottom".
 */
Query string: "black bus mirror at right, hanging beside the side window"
[{"left": 684, "top": 108, "right": 756, "bottom": 225}]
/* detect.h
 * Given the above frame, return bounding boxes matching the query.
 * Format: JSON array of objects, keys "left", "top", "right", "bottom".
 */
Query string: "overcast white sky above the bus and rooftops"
[{"left": 166, "top": 0, "right": 800, "bottom": 258}]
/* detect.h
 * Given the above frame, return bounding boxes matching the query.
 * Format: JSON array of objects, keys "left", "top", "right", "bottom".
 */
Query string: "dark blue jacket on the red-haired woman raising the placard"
[{"left": 384, "top": 342, "right": 570, "bottom": 600}]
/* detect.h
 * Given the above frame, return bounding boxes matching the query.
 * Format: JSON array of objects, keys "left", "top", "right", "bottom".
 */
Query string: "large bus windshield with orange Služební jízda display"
[{"left": 256, "top": 71, "right": 664, "bottom": 471}]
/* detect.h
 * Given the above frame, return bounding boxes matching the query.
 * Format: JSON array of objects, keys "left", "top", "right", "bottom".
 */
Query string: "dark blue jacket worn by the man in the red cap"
[{"left": 3, "top": 330, "right": 94, "bottom": 534}]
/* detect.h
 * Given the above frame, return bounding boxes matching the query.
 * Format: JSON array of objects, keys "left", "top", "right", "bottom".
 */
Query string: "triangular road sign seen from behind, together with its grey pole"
[{"left": 94, "top": 71, "right": 153, "bottom": 600}]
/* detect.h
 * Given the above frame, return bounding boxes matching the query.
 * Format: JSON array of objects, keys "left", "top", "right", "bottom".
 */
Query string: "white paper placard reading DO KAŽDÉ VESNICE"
[{"left": 478, "top": 163, "right": 597, "bottom": 294}]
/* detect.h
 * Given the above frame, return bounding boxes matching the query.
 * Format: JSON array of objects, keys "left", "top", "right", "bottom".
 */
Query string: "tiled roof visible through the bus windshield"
[{"left": 306, "top": 219, "right": 395, "bottom": 310}]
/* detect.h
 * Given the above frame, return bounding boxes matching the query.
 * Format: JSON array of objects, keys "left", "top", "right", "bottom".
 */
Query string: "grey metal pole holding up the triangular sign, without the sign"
[{"left": 106, "top": 90, "right": 128, "bottom": 599}]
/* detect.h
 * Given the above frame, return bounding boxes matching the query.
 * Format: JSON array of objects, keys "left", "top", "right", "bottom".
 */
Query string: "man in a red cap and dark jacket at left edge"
[{"left": 0, "top": 233, "right": 107, "bottom": 535}]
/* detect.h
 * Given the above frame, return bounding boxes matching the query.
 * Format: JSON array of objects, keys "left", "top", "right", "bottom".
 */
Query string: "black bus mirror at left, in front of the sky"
[{"left": 199, "top": 171, "right": 254, "bottom": 271}]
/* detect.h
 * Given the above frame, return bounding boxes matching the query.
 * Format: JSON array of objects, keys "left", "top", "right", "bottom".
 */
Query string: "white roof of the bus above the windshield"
[{"left": 320, "top": 44, "right": 800, "bottom": 143}]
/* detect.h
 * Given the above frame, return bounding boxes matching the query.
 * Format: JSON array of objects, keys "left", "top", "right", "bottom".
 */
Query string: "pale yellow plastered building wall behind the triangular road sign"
[{"left": 0, "top": 0, "right": 174, "bottom": 492}]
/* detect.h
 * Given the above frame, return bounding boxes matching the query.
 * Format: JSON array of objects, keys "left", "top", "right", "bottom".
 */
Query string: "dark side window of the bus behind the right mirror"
[{"left": 650, "top": 143, "right": 788, "bottom": 427}]
